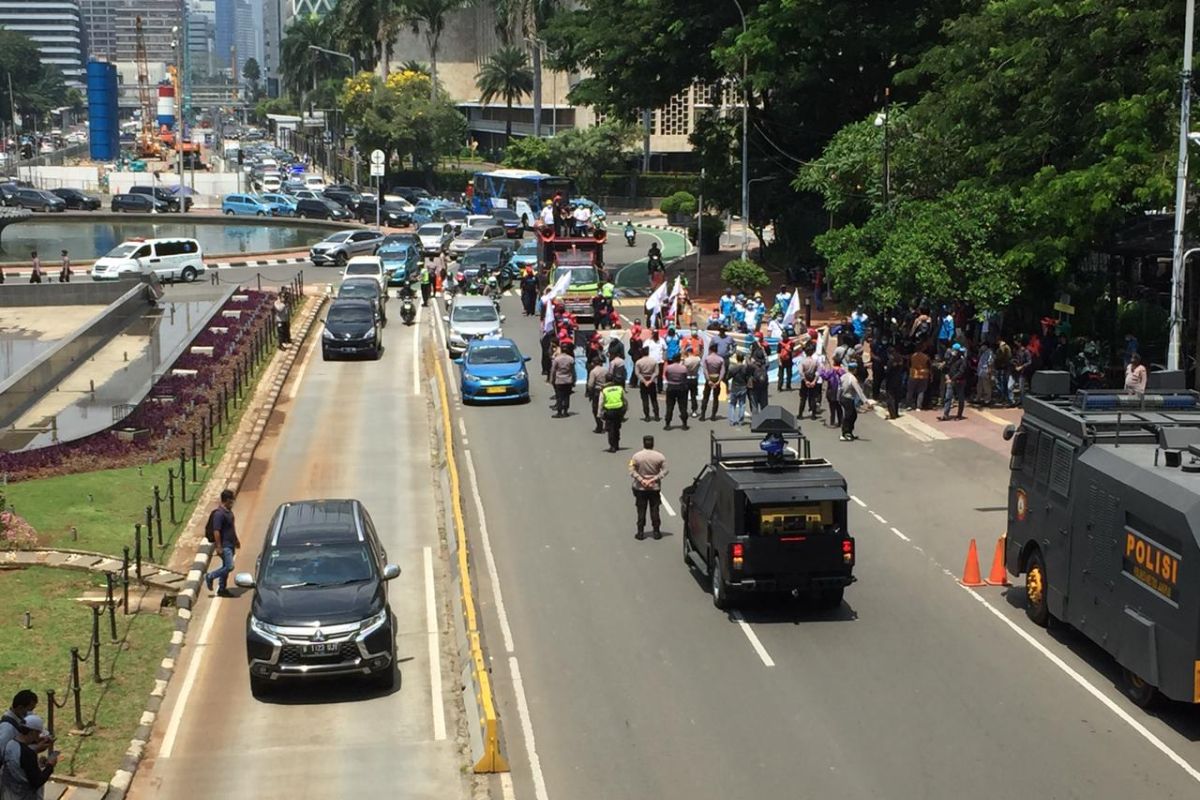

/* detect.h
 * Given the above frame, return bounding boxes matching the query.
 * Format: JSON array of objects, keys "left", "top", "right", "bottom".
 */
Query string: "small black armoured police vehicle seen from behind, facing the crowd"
[{"left": 680, "top": 405, "right": 854, "bottom": 609}]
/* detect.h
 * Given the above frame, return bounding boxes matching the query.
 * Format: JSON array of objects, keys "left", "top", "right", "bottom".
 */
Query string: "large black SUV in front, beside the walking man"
[{"left": 234, "top": 500, "right": 400, "bottom": 696}]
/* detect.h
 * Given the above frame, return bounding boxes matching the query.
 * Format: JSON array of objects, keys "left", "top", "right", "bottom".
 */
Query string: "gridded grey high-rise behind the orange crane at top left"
[{"left": 80, "top": 0, "right": 185, "bottom": 64}]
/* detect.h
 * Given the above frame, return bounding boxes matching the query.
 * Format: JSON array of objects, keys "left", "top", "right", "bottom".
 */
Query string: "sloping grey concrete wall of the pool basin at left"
[{"left": 0, "top": 281, "right": 150, "bottom": 427}]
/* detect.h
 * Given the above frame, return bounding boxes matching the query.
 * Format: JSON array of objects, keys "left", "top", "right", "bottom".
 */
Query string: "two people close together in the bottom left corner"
[{"left": 0, "top": 688, "right": 59, "bottom": 800}]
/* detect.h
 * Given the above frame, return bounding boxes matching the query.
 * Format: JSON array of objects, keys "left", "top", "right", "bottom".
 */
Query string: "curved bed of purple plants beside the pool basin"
[{"left": 0, "top": 290, "right": 282, "bottom": 482}]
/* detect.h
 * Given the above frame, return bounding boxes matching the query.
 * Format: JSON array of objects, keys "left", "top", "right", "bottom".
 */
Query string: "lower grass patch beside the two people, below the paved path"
[{"left": 0, "top": 567, "right": 173, "bottom": 781}]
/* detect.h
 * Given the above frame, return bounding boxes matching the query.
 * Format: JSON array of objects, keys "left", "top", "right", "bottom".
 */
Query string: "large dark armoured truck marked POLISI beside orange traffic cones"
[{"left": 1004, "top": 372, "right": 1200, "bottom": 705}]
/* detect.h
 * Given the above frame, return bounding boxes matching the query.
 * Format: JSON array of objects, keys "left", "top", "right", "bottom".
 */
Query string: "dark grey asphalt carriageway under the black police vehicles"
[{"left": 451, "top": 293, "right": 1200, "bottom": 800}]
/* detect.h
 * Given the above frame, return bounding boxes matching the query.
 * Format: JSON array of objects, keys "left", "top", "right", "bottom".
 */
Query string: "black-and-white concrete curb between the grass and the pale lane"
[{"left": 104, "top": 296, "right": 325, "bottom": 800}]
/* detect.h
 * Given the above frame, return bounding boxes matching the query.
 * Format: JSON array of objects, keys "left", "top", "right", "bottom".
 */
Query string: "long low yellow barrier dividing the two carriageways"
[{"left": 433, "top": 340, "right": 509, "bottom": 772}]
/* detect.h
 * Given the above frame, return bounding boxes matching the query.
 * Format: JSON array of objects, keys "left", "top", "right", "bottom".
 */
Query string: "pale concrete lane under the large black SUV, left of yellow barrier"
[{"left": 132, "top": 284, "right": 467, "bottom": 800}]
